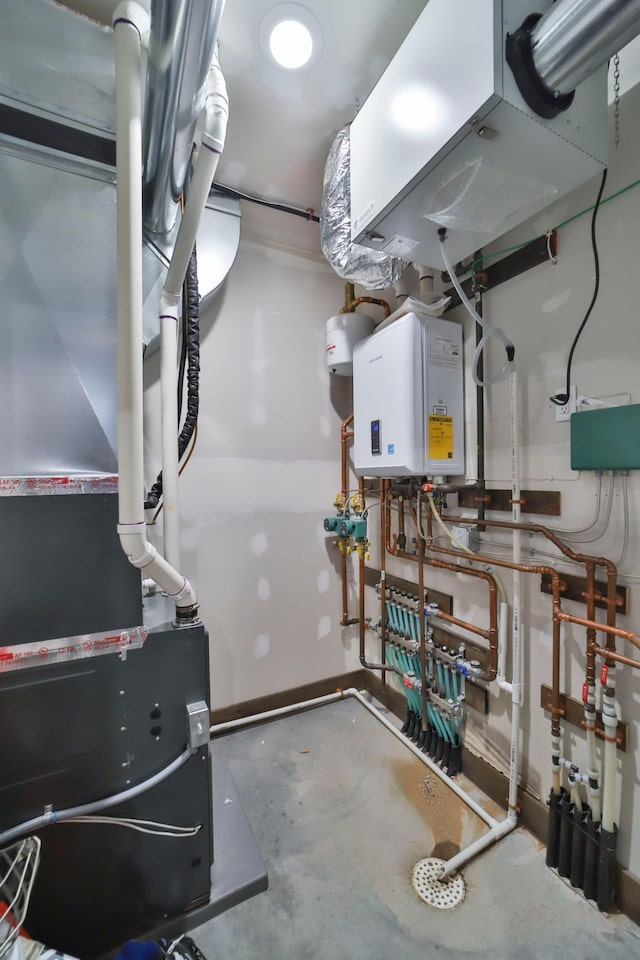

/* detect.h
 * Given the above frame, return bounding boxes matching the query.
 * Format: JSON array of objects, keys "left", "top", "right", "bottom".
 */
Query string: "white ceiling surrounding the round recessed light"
[{"left": 63, "top": 0, "right": 640, "bottom": 252}]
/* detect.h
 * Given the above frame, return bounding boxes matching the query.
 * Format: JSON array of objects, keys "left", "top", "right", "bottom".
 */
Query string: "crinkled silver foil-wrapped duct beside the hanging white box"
[{"left": 320, "top": 126, "right": 407, "bottom": 290}]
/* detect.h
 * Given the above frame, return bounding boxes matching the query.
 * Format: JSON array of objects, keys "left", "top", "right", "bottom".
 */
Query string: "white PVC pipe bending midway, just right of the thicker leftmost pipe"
[{"left": 160, "top": 54, "right": 229, "bottom": 569}]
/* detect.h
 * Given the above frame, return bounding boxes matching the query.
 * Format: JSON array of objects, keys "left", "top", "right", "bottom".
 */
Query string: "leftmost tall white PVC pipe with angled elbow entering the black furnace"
[{"left": 113, "top": 0, "right": 196, "bottom": 607}]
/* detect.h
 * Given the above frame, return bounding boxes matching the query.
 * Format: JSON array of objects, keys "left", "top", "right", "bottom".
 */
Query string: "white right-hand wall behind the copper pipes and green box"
[{"left": 362, "top": 88, "right": 640, "bottom": 876}]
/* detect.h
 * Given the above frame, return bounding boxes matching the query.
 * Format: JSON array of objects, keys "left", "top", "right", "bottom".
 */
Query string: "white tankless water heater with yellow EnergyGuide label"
[{"left": 353, "top": 313, "right": 464, "bottom": 477}]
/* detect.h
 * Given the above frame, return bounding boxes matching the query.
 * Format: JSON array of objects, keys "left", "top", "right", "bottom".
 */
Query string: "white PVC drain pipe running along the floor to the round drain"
[{"left": 211, "top": 687, "right": 517, "bottom": 880}]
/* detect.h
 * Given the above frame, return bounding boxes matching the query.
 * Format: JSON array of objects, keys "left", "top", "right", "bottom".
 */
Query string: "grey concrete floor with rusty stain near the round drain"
[{"left": 192, "top": 700, "right": 640, "bottom": 960}]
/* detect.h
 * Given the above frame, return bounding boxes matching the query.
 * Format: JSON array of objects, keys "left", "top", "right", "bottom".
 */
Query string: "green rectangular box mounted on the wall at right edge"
[{"left": 571, "top": 403, "right": 640, "bottom": 470}]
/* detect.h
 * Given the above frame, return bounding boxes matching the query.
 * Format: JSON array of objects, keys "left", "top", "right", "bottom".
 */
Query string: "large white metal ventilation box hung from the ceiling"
[{"left": 350, "top": 0, "right": 608, "bottom": 267}]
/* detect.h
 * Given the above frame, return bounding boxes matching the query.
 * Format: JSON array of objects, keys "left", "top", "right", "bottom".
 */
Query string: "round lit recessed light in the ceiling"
[{"left": 260, "top": 3, "right": 322, "bottom": 70}]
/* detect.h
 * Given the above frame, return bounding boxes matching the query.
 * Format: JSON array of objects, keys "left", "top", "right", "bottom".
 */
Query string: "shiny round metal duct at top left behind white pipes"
[{"left": 143, "top": 0, "right": 225, "bottom": 234}]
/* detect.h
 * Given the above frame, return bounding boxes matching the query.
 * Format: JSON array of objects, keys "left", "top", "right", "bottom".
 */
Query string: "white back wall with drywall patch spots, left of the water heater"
[{"left": 145, "top": 236, "right": 358, "bottom": 707}]
